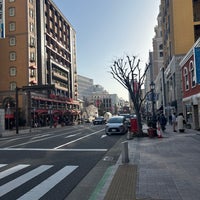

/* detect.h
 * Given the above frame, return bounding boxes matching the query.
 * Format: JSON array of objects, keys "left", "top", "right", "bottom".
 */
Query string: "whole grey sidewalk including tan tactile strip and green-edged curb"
[{"left": 94, "top": 126, "right": 200, "bottom": 200}]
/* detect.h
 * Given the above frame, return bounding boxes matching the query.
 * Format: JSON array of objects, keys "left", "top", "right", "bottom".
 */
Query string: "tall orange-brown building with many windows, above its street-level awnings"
[{"left": 0, "top": 0, "right": 78, "bottom": 128}]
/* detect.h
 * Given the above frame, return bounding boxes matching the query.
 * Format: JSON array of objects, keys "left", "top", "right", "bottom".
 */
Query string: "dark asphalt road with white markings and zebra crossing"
[{"left": 0, "top": 124, "right": 125, "bottom": 200}]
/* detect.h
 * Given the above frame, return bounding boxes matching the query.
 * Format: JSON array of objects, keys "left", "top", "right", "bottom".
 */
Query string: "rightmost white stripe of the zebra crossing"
[{"left": 17, "top": 166, "right": 78, "bottom": 200}]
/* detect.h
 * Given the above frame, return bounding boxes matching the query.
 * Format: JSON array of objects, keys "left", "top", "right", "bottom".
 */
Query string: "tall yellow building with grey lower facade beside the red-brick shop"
[{"left": 161, "top": 0, "right": 200, "bottom": 115}]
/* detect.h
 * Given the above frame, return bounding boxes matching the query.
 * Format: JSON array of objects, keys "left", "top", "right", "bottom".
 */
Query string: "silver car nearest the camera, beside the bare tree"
[{"left": 105, "top": 116, "right": 128, "bottom": 135}]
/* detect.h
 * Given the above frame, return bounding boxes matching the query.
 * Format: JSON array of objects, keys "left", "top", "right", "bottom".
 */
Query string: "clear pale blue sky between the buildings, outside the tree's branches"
[{"left": 53, "top": 0, "right": 160, "bottom": 100}]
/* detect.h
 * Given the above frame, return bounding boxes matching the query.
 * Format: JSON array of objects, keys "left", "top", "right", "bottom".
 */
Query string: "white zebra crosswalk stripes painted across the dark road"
[{"left": 0, "top": 164, "right": 78, "bottom": 200}]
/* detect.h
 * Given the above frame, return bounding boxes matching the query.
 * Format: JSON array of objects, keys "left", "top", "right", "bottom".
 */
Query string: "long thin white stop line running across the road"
[{"left": 0, "top": 148, "right": 108, "bottom": 152}]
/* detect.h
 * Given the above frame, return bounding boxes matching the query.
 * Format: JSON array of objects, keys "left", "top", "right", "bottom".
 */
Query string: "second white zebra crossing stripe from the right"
[{"left": 0, "top": 165, "right": 53, "bottom": 197}]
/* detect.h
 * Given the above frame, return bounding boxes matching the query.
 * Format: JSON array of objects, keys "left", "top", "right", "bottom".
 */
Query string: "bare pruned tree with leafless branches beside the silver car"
[{"left": 110, "top": 56, "right": 148, "bottom": 135}]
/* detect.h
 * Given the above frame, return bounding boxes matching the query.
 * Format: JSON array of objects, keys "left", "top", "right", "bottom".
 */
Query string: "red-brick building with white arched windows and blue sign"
[{"left": 180, "top": 38, "right": 200, "bottom": 129}]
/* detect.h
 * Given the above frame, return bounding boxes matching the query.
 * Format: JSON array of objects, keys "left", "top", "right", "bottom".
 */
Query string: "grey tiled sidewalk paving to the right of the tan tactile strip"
[{"left": 129, "top": 127, "right": 200, "bottom": 200}]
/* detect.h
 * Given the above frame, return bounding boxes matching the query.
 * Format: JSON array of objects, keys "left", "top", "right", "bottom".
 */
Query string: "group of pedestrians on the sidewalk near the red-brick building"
[{"left": 157, "top": 113, "right": 186, "bottom": 132}]
